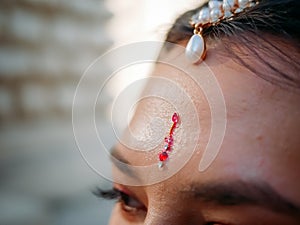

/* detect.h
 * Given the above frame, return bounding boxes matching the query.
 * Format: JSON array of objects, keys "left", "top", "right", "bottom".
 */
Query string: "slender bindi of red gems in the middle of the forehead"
[{"left": 158, "top": 112, "right": 180, "bottom": 168}]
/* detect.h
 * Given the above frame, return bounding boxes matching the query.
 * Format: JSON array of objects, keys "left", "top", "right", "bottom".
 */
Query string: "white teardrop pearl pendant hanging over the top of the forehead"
[{"left": 185, "top": 34, "right": 206, "bottom": 63}]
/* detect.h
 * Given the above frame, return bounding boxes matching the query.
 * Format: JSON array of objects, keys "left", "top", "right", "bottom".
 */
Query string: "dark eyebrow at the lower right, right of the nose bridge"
[{"left": 189, "top": 180, "right": 300, "bottom": 218}]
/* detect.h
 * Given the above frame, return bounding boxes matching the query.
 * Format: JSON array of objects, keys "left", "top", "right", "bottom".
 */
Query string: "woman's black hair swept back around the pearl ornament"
[{"left": 166, "top": 0, "right": 300, "bottom": 89}]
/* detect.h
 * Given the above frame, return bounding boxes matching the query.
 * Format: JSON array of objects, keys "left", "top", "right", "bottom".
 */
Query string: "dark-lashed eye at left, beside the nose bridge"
[{"left": 93, "top": 188, "right": 146, "bottom": 214}]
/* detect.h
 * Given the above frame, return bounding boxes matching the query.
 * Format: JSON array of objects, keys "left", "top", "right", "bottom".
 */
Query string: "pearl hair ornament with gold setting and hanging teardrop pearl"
[{"left": 185, "top": 0, "right": 258, "bottom": 64}]
